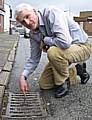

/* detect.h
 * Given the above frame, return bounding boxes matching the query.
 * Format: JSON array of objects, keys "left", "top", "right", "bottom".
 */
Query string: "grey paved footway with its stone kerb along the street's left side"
[{"left": 0, "top": 33, "right": 19, "bottom": 111}]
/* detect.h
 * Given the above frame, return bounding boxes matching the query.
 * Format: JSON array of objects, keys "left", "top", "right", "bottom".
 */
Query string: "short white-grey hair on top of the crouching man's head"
[{"left": 14, "top": 3, "right": 34, "bottom": 19}]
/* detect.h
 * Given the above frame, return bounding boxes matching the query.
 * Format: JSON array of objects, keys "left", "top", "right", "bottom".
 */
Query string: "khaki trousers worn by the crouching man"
[{"left": 39, "top": 42, "right": 91, "bottom": 89}]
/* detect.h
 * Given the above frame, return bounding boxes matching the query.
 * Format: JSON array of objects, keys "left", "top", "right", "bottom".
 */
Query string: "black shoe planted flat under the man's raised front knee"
[{"left": 55, "top": 78, "right": 70, "bottom": 98}]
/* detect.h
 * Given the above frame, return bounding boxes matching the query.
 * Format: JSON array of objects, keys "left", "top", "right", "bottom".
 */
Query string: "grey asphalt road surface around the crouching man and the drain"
[{"left": 1, "top": 36, "right": 92, "bottom": 120}]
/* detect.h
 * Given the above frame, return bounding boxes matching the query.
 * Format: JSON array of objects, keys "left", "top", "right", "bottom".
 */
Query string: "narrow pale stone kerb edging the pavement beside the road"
[{"left": 0, "top": 34, "right": 19, "bottom": 111}]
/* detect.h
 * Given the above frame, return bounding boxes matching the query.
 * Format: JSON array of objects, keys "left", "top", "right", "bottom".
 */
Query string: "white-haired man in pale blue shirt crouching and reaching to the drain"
[{"left": 15, "top": 3, "right": 91, "bottom": 98}]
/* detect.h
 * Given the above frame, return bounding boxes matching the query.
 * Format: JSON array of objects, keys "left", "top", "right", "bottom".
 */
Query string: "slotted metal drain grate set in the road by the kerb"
[{"left": 3, "top": 92, "right": 47, "bottom": 120}]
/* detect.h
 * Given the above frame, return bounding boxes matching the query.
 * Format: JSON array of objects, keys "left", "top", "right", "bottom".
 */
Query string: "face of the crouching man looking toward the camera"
[{"left": 16, "top": 9, "right": 38, "bottom": 30}]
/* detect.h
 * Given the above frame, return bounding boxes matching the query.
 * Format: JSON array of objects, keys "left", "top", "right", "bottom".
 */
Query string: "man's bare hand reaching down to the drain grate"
[{"left": 19, "top": 75, "right": 29, "bottom": 93}]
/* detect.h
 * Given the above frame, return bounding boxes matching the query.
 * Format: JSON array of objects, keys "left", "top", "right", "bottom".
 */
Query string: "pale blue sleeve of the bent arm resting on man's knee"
[{"left": 44, "top": 9, "right": 72, "bottom": 48}]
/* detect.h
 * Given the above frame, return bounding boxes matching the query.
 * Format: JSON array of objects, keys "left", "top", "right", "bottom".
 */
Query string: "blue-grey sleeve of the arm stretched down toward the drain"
[{"left": 22, "top": 39, "right": 41, "bottom": 77}]
